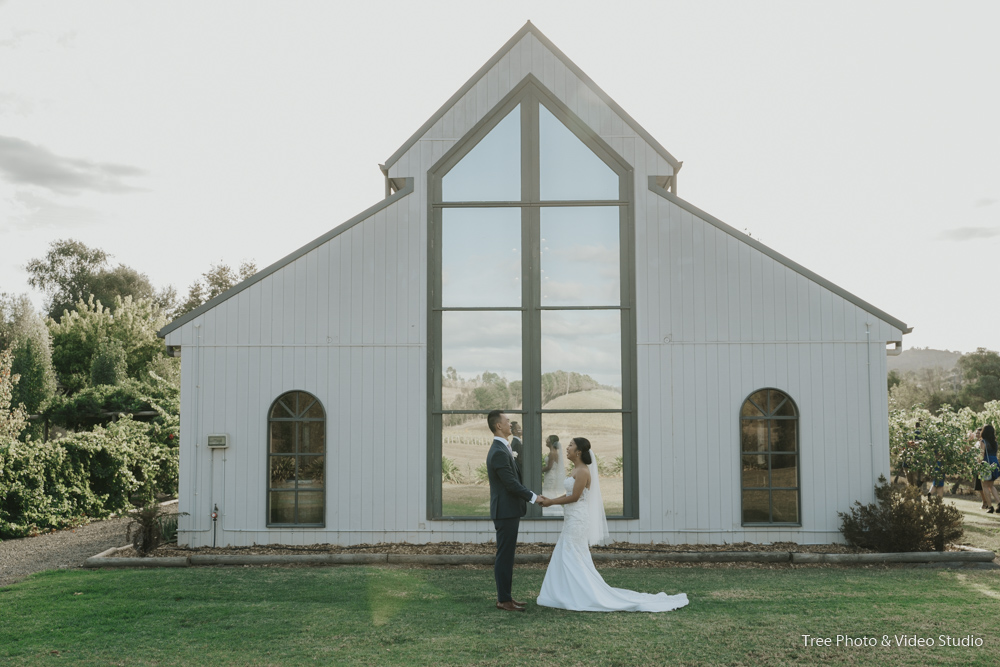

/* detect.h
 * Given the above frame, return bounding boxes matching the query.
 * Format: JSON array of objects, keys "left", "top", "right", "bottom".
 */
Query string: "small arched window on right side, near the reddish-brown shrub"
[{"left": 740, "top": 389, "right": 801, "bottom": 526}]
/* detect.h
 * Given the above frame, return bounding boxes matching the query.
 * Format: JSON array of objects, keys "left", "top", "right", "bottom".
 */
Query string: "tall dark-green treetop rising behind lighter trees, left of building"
[{"left": 25, "top": 239, "right": 177, "bottom": 321}]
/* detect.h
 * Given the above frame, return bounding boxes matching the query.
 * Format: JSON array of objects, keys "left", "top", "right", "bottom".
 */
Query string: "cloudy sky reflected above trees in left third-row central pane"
[{"left": 441, "top": 310, "right": 521, "bottom": 381}]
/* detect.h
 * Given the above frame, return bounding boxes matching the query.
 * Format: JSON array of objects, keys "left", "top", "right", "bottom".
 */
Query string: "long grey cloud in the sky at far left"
[{"left": 0, "top": 135, "right": 145, "bottom": 194}]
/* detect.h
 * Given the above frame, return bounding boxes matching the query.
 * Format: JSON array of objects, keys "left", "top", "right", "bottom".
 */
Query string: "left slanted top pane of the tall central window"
[{"left": 441, "top": 105, "right": 524, "bottom": 201}]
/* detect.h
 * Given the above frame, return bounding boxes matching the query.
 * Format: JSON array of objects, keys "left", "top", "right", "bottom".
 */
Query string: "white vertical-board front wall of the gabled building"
[{"left": 166, "top": 27, "right": 902, "bottom": 546}]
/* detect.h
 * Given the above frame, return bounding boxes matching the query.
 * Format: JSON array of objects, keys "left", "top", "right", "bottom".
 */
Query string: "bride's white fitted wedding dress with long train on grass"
[{"left": 537, "top": 477, "right": 688, "bottom": 611}]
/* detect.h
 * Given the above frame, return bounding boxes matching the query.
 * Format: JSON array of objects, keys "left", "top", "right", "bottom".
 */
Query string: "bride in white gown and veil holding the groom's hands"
[{"left": 537, "top": 438, "right": 688, "bottom": 611}]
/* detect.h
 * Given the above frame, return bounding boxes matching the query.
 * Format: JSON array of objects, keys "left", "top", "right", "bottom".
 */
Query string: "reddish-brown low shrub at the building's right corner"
[{"left": 837, "top": 475, "right": 964, "bottom": 552}]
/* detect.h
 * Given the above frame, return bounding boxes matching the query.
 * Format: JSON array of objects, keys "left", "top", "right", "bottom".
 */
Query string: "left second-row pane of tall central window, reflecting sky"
[{"left": 441, "top": 208, "right": 521, "bottom": 307}]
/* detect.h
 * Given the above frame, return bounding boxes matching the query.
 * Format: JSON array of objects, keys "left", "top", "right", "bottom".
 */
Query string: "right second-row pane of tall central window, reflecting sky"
[{"left": 540, "top": 206, "right": 621, "bottom": 306}]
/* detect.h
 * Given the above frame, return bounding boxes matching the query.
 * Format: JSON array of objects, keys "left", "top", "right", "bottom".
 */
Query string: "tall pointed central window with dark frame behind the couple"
[{"left": 428, "top": 84, "right": 638, "bottom": 518}]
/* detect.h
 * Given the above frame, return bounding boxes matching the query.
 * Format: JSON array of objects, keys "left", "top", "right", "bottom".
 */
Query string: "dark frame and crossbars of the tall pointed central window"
[{"left": 427, "top": 74, "right": 639, "bottom": 519}]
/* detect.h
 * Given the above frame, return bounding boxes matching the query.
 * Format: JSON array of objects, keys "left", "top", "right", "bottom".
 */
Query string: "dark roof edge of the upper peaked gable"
[{"left": 380, "top": 21, "right": 683, "bottom": 174}]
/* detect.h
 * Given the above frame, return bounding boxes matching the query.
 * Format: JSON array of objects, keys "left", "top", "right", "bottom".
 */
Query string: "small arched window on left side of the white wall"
[{"left": 267, "top": 391, "right": 326, "bottom": 527}]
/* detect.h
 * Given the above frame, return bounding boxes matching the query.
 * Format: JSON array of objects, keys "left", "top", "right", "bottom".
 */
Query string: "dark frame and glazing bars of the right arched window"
[{"left": 737, "top": 387, "right": 802, "bottom": 526}]
